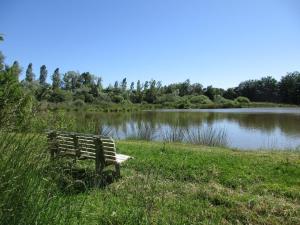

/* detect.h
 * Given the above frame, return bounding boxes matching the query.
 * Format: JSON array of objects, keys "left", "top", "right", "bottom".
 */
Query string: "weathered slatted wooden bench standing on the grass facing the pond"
[{"left": 47, "top": 131, "right": 132, "bottom": 177}]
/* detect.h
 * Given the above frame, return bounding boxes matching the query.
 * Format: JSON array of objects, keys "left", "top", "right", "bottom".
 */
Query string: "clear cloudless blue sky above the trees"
[{"left": 0, "top": 0, "right": 300, "bottom": 88}]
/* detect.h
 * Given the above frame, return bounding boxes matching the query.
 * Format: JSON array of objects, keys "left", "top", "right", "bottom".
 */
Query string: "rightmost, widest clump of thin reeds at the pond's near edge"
[{"left": 185, "top": 126, "right": 228, "bottom": 146}]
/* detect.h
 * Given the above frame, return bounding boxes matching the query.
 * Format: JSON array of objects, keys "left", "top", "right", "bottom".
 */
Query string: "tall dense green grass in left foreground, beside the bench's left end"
[{"left": 0, "top": 133, "right": 83, "bottom": 225}]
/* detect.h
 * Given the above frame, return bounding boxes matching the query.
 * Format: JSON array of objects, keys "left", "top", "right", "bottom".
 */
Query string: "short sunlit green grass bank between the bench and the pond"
[{"left": 0, "top": 134, "right": 300, "bottom": 224}]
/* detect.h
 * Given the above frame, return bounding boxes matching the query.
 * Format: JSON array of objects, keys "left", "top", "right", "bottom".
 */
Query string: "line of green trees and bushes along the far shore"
[{"left": 0, "top": 50, "right": 300, "bottom": 108}]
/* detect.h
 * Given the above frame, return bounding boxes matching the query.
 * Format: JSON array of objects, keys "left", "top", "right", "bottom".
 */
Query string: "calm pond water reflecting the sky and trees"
[{"left": 75, "top": 108, "right": 300, "bottom": 149}]
